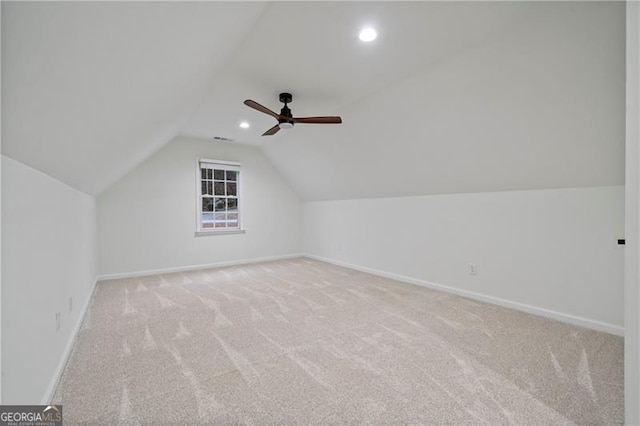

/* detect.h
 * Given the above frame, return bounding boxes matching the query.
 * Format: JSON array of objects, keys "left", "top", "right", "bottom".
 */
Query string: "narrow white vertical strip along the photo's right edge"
[{"left": 624, "top": 1, "right": 640, "bottom": 425}]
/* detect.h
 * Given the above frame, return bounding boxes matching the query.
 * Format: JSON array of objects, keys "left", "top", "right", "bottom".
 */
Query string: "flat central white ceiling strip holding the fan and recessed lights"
[{"left": 181, "top": 2, "right": 530, "bottom": 145}]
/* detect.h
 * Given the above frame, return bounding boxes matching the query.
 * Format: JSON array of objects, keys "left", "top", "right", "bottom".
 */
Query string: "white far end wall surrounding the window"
[{"left": 98, "top": 138, "right": 302, "bottom": 276}]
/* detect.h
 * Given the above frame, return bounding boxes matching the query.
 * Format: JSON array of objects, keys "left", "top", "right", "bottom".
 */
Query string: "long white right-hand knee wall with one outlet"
[{"left": 303, "top": 186, "right": 624, "bottom": 334}]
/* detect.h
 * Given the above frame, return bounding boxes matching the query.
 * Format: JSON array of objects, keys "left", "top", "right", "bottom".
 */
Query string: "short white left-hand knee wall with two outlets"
[{"left": 2, "top": 156, "right": 96, "bottom": 404}]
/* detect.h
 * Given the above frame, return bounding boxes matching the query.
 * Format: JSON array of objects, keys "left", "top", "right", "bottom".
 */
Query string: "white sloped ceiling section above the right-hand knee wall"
[{"left": 255, "top": 2, "right": 625, "bottom": 200}]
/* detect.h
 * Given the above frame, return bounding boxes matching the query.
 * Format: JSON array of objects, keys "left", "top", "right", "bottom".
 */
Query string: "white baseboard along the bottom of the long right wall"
[{"left": 304, "top": 254, "right": 624, "bottom": 337}]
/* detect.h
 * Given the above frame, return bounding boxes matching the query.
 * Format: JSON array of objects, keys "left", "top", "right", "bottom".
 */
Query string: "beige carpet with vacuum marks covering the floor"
[{"left": 54, "top": 258, "right": 624, "bottom": 425}]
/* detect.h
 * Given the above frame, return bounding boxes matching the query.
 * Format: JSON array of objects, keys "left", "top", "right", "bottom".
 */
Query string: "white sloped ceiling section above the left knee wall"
[{"left": 2, "top": 1, "right": 265, "bottom": 194}]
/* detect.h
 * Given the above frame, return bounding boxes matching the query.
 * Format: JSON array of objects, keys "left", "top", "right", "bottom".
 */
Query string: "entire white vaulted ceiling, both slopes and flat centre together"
[{"left": 2, "top": 1, "right": 625, "bottom": 200}]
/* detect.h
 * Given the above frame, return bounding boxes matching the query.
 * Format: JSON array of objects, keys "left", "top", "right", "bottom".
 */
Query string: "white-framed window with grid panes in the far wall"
[{"left": 197, "top": 160, "right": 241, "bottom": 233}]
